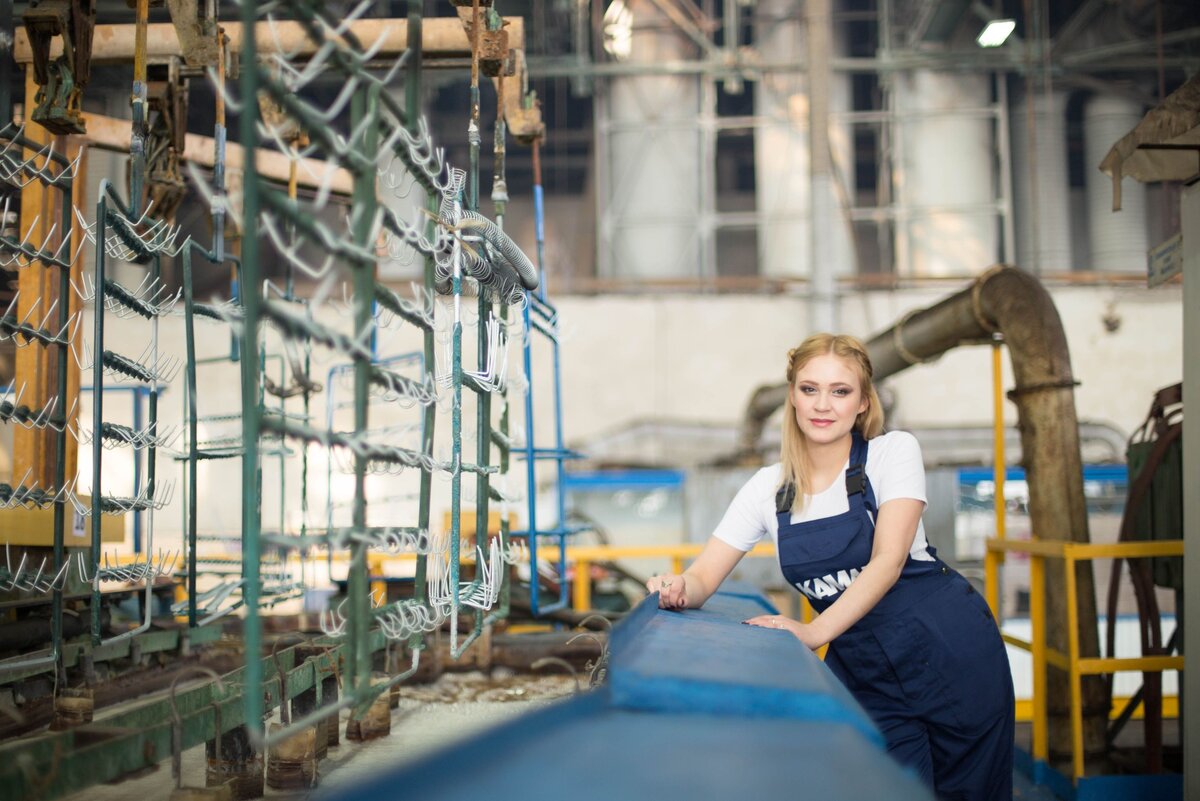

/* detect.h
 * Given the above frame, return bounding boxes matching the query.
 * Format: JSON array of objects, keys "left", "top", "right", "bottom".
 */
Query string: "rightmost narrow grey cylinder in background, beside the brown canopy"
[{"left": 1084, "top": 95, "right": 1150, "bottom": 272}]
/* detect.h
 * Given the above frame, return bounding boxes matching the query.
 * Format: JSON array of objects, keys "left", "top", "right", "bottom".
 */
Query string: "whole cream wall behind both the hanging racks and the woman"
[{"left": 70, "top": 276, "right": 1183, "bottom": 556}]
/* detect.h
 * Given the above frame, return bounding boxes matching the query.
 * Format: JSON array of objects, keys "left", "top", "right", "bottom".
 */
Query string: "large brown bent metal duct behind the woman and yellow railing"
[{"left": 740, "top": 265, "right": 1110, "bottom": 755}]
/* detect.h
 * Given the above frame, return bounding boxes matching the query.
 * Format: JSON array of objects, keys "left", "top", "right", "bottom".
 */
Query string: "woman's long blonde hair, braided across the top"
[{"left": 779, "top": 333, "right": 883, "bottom": 507}]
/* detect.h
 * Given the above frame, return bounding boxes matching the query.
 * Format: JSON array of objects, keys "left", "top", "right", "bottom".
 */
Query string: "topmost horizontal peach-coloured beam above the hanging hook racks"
[{"left": 13, "top": 17, "right": 524, "bottom": 65}]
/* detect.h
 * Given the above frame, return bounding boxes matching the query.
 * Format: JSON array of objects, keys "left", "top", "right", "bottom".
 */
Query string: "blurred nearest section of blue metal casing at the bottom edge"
[{"left": 337, "top": 692, "right": 932, "bottom": 801}]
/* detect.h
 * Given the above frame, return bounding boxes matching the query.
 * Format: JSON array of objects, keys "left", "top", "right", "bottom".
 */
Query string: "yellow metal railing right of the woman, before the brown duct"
[{"left": 984, "top": 538, "right": 1183, "bottom": 782}]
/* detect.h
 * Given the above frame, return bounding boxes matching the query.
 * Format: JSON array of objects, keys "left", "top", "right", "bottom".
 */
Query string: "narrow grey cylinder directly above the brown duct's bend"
[{"left": 1009, "top": 91, "right": 1073, "bottom": 275}]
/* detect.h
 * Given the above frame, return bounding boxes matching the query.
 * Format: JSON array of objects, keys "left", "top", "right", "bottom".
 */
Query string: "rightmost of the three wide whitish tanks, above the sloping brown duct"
[{"left": 894, "top": 70, "right": 1000, "bottom": 277}]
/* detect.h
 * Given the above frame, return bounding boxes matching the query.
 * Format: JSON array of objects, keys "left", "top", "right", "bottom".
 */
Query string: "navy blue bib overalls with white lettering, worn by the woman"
[{"left": 775, "top": 430, "right": 1014, "bottom": 801}]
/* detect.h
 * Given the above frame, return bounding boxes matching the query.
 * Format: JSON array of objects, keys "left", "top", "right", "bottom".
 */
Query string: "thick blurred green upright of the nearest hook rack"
[{"left": 240, "top": 2, "right": 263, "bottom": 741}]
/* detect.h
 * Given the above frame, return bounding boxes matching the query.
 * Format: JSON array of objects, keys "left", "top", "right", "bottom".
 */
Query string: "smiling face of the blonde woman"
[{"left": 792, "top": 354, "right": 868, "bottom": 445}]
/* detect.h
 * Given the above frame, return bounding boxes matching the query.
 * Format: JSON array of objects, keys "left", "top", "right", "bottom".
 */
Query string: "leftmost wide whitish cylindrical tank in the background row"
[{"left": 596, "top": 0, "right": 707, "bottom": 279}]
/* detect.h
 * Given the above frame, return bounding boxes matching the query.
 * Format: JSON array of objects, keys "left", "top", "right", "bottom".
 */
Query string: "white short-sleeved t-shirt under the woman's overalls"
[{"left": 713, "top": 432, "right": 934, "bottom": 561}]
